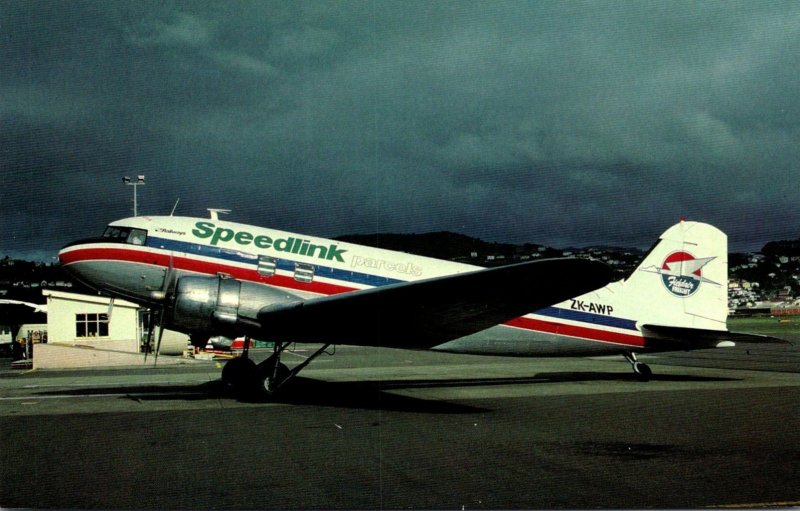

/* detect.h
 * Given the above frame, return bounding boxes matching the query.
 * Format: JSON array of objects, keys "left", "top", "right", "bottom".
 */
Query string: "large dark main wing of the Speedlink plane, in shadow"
[{"left": 258, "top": 259, "right": 612, "bottom": 348}]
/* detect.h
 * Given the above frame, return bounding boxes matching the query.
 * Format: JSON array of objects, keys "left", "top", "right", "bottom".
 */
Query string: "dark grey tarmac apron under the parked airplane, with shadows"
[{"left": 0, "top": 342, "right": 800, "bottom": 509}]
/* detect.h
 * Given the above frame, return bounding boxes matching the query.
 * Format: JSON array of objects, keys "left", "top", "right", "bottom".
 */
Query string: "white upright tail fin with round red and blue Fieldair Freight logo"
[{"left": 616, "top": 221, "right": 728, "bottom": 331}]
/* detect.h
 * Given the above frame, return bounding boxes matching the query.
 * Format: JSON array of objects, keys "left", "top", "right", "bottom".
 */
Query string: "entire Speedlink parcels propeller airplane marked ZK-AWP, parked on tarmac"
[{"left": 59, "top": 210, "right": 778, "bottom": 396}]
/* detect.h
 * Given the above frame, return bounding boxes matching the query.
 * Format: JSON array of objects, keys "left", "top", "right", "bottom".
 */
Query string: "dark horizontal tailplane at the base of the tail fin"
[{"left": 642, "top": 325, "right": 791, "bottom": 350}]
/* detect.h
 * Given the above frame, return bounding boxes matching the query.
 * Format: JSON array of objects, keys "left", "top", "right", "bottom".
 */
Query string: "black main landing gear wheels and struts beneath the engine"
[{"left": 222, "top": 337, "right": 330, "bottom": 397}]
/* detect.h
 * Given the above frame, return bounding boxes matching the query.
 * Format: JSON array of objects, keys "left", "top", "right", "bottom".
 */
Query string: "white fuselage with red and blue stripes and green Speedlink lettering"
[{"left": 59, "top": 216, "right": 664, "bottom": 356}]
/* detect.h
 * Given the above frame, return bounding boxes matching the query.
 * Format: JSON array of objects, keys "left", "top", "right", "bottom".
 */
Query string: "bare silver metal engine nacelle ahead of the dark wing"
[{"left": 169, "top": 276, "right": 302, "bottom": 336}]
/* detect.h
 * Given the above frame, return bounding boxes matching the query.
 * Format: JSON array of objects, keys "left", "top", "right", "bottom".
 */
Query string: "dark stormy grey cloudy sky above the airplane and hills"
[{"left": 0, "top": 0, "right": 800, "bottom": 261}]
